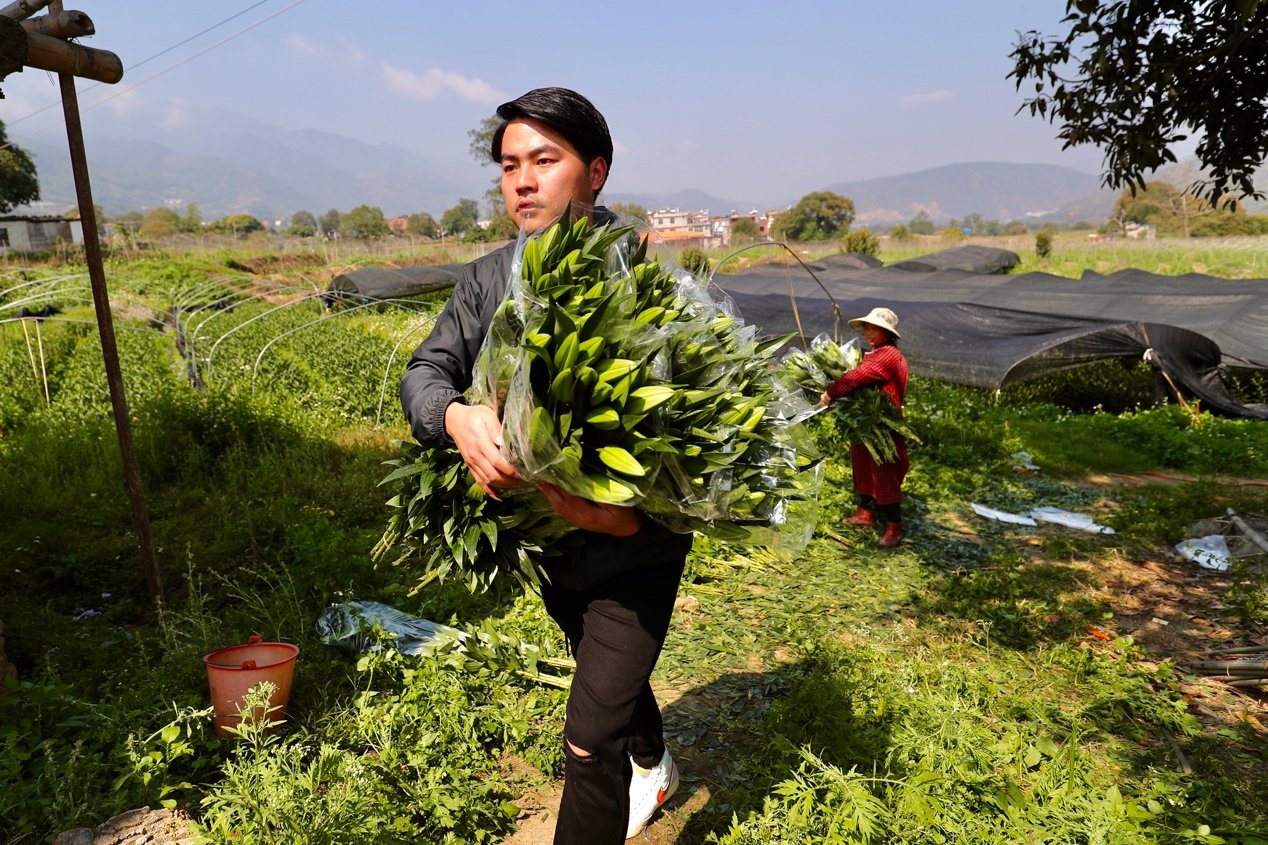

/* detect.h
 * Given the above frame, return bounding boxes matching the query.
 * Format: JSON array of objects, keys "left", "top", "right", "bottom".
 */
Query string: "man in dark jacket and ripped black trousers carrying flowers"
[{"left": 401, "top": 88, "right": 691, "bottom": 845}]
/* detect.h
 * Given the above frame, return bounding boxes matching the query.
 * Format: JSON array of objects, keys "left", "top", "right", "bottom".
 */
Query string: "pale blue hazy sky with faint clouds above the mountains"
[{"left": 7, "top": 0, "right": 1120, "bottom": 206}]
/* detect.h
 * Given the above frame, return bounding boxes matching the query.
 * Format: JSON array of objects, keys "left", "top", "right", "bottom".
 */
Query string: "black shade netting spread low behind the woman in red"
[{"left": 713, "top": 246, "right": 1268, "bottom": 419}]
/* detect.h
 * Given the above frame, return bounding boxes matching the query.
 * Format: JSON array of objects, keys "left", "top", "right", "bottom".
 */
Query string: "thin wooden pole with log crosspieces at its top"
[{"left": 0, "top": 0, "right": 162, "bottom": 605}]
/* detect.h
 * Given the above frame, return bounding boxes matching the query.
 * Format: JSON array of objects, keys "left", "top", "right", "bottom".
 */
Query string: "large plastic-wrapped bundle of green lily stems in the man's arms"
[{"left": 473, "top": 206, "right": 822, "bottom": 548}]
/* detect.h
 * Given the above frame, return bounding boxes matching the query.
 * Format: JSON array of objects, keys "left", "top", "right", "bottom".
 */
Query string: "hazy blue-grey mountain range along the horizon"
[{"left": 14, "top": 103, "right": 1151, "bottom": 227}]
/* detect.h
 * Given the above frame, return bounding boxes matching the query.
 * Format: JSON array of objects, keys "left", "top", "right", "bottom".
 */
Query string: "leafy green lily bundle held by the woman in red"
[{"left": 781, "top": 335, "right": 919, "bottom": 463}]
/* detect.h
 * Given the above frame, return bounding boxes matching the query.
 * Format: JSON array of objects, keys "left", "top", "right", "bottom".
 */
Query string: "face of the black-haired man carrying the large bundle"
[{"left": 501, "top": 118, "right": 607, "bottom": 232}]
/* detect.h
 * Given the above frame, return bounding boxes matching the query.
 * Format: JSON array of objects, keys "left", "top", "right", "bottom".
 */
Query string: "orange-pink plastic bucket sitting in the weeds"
[{"left": 203, "top": 637, "right": 299, "bottom": 736}]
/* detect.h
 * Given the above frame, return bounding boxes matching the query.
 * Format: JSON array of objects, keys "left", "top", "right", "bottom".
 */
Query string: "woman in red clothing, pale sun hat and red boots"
[{"left": 819, "top": 308, "right": 910, "bottom": 548}]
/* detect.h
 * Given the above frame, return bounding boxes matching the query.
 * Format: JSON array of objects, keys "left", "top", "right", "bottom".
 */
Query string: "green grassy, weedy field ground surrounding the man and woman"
[{"left": 0, "top": 236, "right": 1268, "bottom": 845}]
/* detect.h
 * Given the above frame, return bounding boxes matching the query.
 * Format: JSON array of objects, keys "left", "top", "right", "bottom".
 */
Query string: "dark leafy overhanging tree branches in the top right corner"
[{"left": 1009, "top": 0, "right": 1268, "bottom": 202}]
